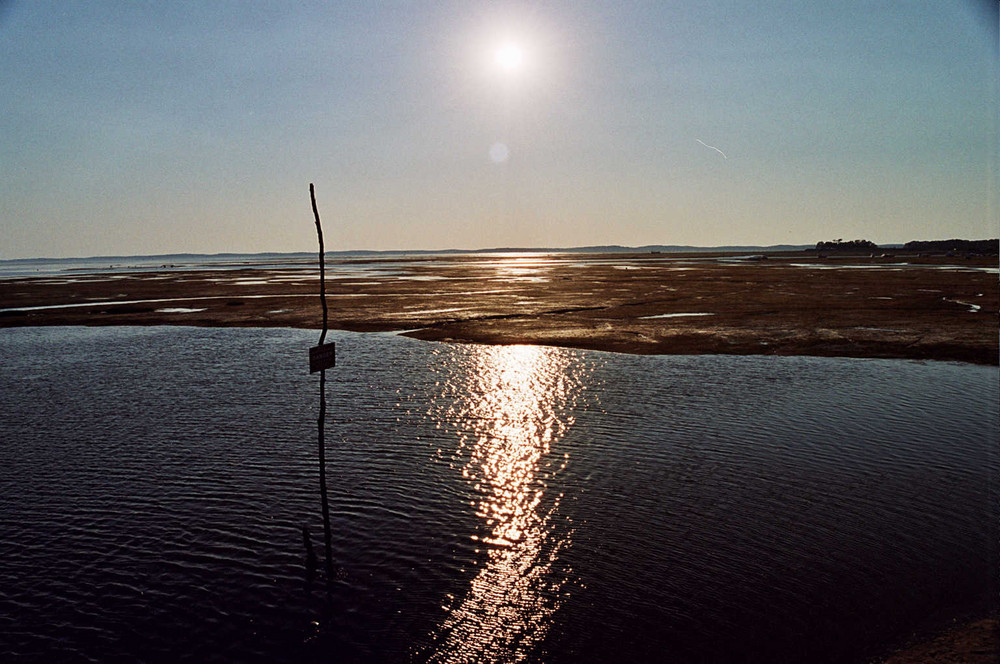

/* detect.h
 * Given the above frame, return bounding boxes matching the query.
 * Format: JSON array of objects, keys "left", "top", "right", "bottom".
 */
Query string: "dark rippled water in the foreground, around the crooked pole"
[{"left": 0, "top": 327, "right": 1000, "bottom": 662}]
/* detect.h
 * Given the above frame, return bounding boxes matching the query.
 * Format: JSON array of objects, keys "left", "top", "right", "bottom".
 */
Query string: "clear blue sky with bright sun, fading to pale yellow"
[{"left": 0, "top": 0, "right": 1000, "bottom": 259}]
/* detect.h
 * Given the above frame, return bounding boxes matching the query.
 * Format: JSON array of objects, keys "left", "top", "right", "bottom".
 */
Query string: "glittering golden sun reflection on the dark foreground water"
[{"left": 430, "top": 346, "right": 579, "bottom": 662}]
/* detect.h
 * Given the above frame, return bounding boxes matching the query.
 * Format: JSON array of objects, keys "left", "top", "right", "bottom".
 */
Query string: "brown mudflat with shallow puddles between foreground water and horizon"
[{"left": 0, "top": 252, "right": 1000, "bottom": 364}]
